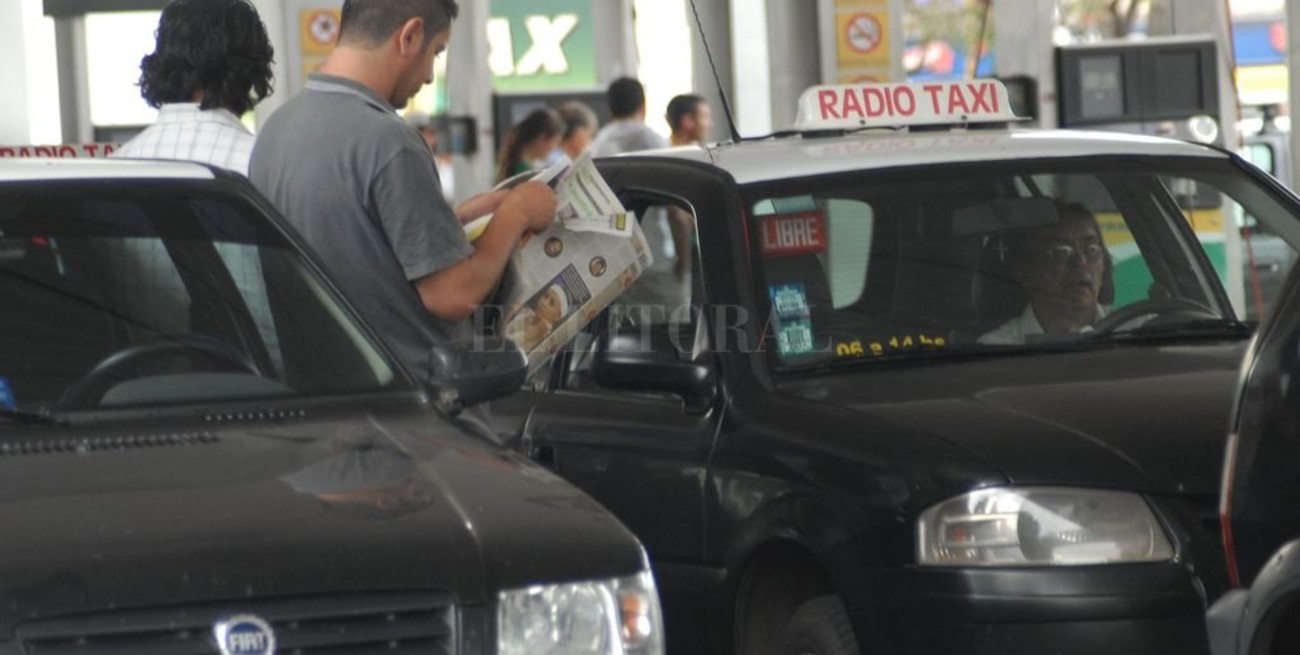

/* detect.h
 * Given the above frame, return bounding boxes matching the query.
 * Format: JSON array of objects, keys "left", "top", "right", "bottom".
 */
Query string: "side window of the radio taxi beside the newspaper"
[{"left": 551, "top": 203, "right": 707, "bottom": 398}]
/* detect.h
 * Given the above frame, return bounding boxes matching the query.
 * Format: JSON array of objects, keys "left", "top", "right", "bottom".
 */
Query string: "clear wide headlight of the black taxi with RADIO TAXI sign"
[{"left": 917, "top": 487, "right": 1174, "bottom": 567}]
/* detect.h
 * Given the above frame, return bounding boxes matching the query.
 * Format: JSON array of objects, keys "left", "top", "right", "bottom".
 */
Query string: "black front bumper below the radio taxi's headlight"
[{"left": 858, "top": 564, "right": 1209, "bottom": 655}]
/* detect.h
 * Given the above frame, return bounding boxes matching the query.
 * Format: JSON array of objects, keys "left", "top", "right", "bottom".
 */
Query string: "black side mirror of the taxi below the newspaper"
[{"left": 592, "top": 325, "right": 718, "bottom": 413}]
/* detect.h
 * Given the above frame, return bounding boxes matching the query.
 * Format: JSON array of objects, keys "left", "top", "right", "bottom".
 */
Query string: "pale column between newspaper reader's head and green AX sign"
[{"left": 446, "top": 0, "right": 497, "bottom": 203}]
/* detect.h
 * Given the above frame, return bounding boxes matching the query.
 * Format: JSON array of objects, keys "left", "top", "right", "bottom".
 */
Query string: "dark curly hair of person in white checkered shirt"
[{"left": 139, "top": 0, "right": 276, "bottom": 116}]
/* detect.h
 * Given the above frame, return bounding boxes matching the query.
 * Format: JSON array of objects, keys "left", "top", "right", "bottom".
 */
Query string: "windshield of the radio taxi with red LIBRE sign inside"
[{"left": 746, "top": 157, "right": 1300, "bottom": 368}]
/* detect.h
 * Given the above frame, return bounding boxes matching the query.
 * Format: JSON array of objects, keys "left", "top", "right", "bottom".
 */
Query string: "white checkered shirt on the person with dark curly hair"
[{"left": 113, "top": 103, "right": 254, "bottom": 175}]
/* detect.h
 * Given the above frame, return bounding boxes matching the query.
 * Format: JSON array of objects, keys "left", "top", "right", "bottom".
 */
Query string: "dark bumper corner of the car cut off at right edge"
[{"left": 1205, "top": 541, "right": 1300, "bottom": 655}]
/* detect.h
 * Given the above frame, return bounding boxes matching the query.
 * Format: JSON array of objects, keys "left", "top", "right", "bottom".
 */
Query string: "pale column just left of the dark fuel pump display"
[{"left": 993, "top": 0, "right": 1057, "bottom": 127}]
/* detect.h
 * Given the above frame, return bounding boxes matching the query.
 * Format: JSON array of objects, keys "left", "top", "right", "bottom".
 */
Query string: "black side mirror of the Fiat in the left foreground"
[{"left": 429, "top": 337, "right": 528, "bottom": 416}]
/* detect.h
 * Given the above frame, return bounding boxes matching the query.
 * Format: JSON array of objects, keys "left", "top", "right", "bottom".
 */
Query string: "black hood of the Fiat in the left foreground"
[{"left": 0, "top": 411, "right": 642, "bottom": 634}]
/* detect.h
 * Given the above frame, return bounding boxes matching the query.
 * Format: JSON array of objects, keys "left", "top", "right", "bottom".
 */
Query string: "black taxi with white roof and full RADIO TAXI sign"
[{"left": 497, "top": 82, "right": 1300, "bottom": 655}]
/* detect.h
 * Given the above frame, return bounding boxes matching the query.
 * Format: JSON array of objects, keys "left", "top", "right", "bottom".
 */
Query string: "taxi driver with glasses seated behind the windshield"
[{"left": 979, "top": 201, "right": 1110, "bottom": 346}]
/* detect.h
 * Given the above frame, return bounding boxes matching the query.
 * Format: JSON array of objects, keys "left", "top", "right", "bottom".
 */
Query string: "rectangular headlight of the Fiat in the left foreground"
[{"left": 498, "top": 572, "right": 663, "bottom": 655}]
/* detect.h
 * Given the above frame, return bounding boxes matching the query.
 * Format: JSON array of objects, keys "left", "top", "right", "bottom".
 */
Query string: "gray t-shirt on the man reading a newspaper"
[{"left": 248, "top": 74, "right": 473, "bottom": 381}]
